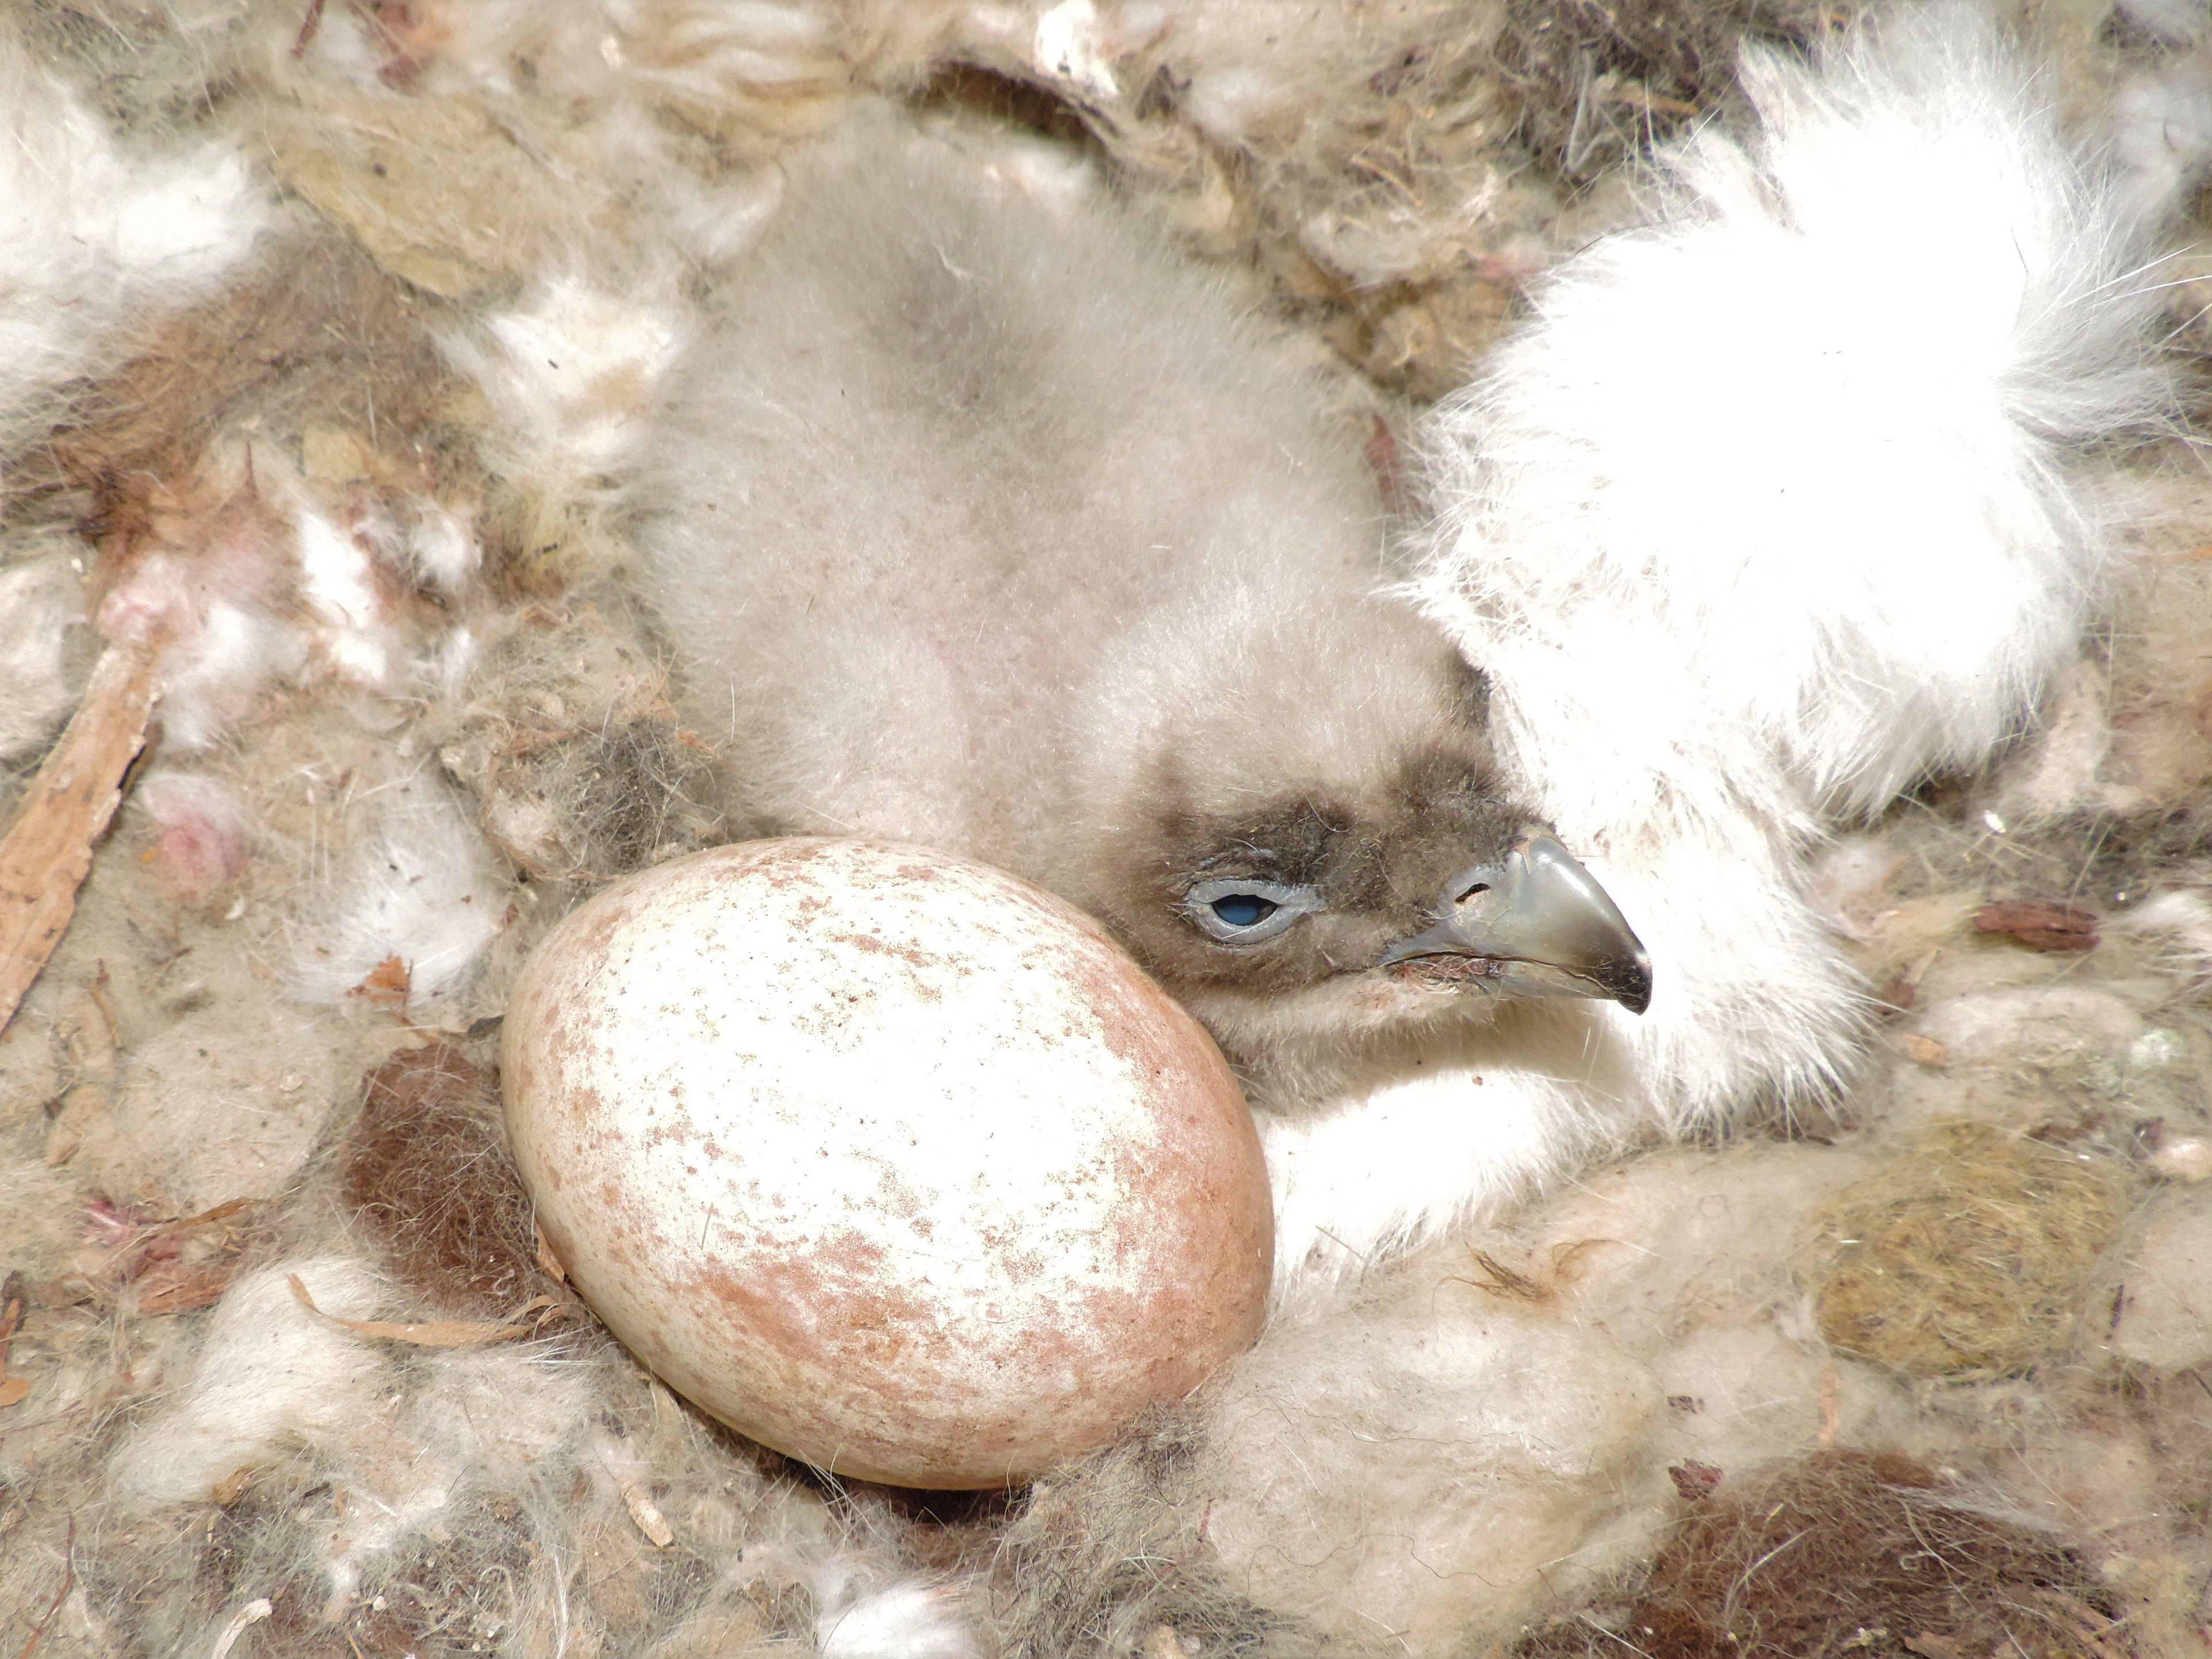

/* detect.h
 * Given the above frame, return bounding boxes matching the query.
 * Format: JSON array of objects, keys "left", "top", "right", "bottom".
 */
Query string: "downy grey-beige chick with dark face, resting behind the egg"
[{"left": 646, "top": 115, "right": 1650, "bottom": 1108}]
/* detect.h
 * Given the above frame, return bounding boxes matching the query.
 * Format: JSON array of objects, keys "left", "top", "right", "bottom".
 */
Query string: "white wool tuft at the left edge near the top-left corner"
[{"left": 0, "top": 29, "right": 272, "bottom": 451}]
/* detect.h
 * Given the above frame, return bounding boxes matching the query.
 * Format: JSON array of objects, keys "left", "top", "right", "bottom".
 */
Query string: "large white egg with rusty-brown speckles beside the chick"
[{"left": 502, "top": 841, "right": 1274, "bottom": 1486}]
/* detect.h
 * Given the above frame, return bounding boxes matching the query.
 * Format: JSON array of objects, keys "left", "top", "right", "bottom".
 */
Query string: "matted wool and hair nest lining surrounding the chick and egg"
[{"left": 0, "top": 0, "right": 2212, "bottom": 1659}]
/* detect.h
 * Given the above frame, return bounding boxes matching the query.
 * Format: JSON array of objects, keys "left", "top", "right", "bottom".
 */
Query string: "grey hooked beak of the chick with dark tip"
[{"left": 1382, "top": 827, "right": 1653, "bottom": 1013}]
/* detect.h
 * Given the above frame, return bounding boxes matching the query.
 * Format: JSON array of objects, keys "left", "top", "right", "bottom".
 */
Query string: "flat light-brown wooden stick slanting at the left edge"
[{"left": 0, "top": 646, "right": 155, "bottom": 1031}]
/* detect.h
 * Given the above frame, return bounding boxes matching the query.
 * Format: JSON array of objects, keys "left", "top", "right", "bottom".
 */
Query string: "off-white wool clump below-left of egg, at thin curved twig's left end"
[{"left": 110, "top": 1256, "right": 385, "bottom": 1507}]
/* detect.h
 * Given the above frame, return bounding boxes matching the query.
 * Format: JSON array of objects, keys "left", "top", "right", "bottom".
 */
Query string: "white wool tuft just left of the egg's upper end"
[{"left": 292, "top": 776, "right": 507, "bottom": 1006}]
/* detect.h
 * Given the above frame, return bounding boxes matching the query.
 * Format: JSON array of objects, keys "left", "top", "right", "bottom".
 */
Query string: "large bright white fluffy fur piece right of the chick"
[{"left": 1270, "top": 9, "right": 2168, "bottom": 1300}]
